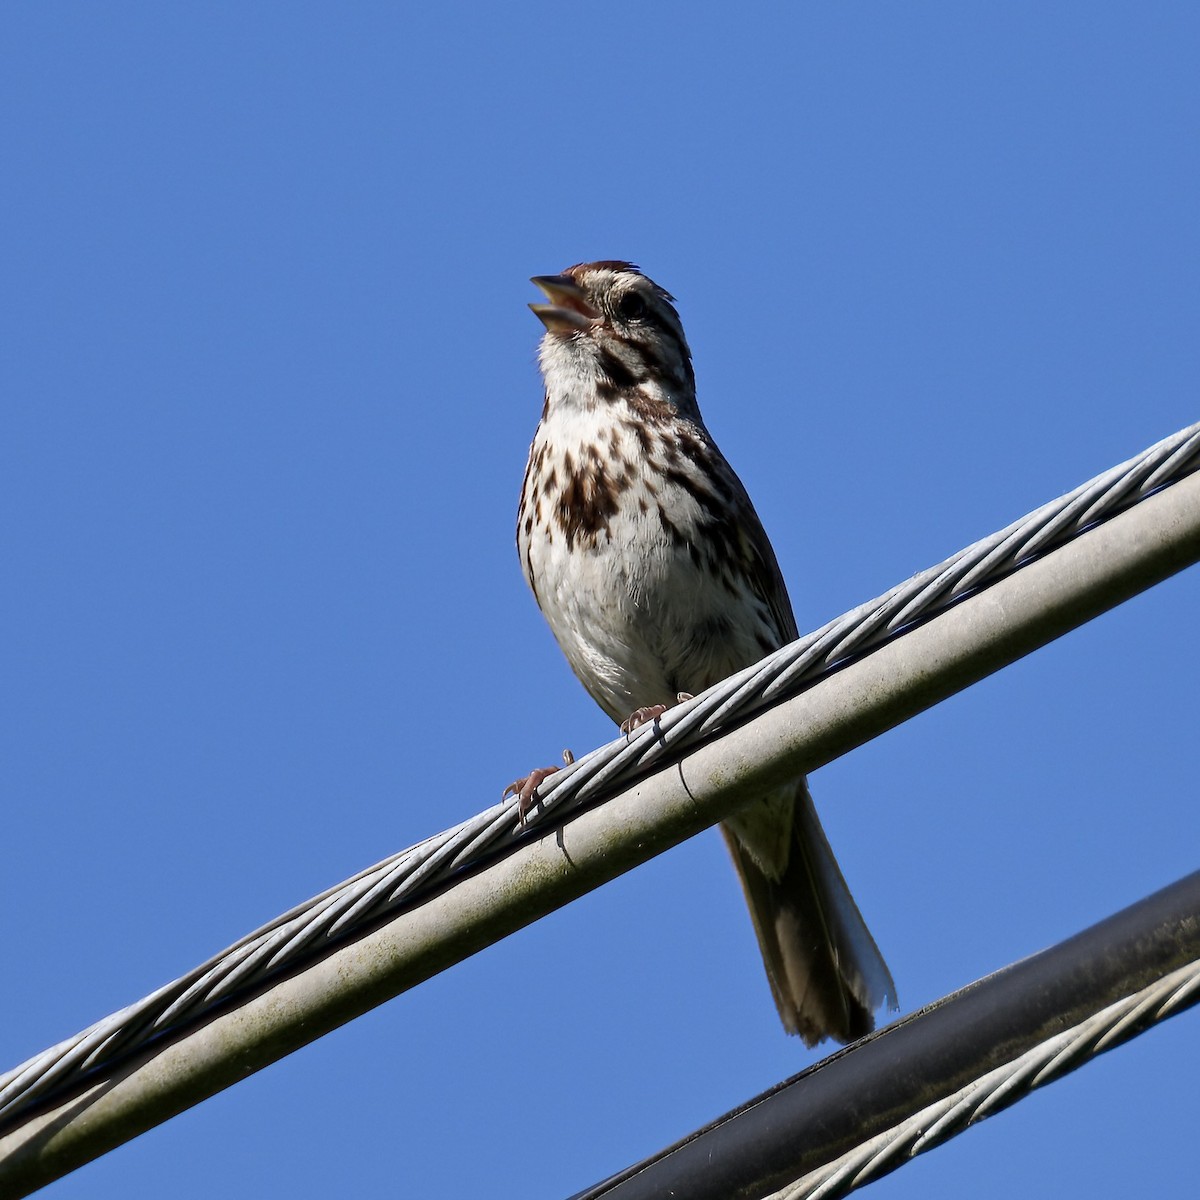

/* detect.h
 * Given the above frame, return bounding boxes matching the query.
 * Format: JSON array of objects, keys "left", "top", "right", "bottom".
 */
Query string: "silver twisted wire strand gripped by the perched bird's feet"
[{"left": 0, "top": 424, "right": 1200, "bottom": 1126}]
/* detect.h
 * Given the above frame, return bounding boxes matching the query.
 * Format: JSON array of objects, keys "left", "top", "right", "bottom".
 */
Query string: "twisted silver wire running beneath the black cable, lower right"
[{"left": 764, "top": 962, "right": 1200, "bottom": 1200}]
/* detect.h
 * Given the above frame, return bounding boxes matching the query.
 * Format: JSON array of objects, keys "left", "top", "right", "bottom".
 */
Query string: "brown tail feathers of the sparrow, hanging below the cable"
[{"left": 721, "top": 780, "right": 896, "bottom": 1046}]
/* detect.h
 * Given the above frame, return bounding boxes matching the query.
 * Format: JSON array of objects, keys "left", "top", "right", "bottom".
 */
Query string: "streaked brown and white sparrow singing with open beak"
[{"left": 514, "top": 262, "right": 895, "bottom": 1045}]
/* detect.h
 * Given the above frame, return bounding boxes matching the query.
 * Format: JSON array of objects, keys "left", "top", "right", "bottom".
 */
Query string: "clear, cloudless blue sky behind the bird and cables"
[{"left": 0, "top": 2, "right": 1200, "bottom": 1200}]
